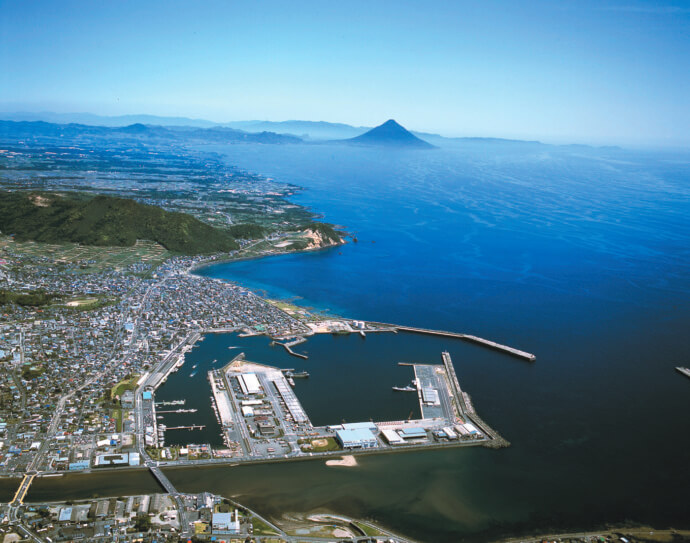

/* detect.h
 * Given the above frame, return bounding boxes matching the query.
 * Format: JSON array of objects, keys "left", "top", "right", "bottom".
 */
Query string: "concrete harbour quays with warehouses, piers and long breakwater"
[{"left": 130, "top": 319, "right": 536, "bottom": 475}]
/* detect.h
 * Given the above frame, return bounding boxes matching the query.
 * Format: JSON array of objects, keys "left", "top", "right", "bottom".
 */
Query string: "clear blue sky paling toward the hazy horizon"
[{"left": 0, "top": 0, "right": 690, "bottom": 146}]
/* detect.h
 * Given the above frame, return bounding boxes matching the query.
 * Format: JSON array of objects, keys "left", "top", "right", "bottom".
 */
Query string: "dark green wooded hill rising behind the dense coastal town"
[{"left": 0, "top": 191, "right": 238, "bottom": 254}]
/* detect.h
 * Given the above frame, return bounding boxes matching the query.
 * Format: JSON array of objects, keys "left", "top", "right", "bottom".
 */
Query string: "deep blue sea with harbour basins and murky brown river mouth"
[{"left": 30, "top": 141, "right": 690, "bottom": 542}]
